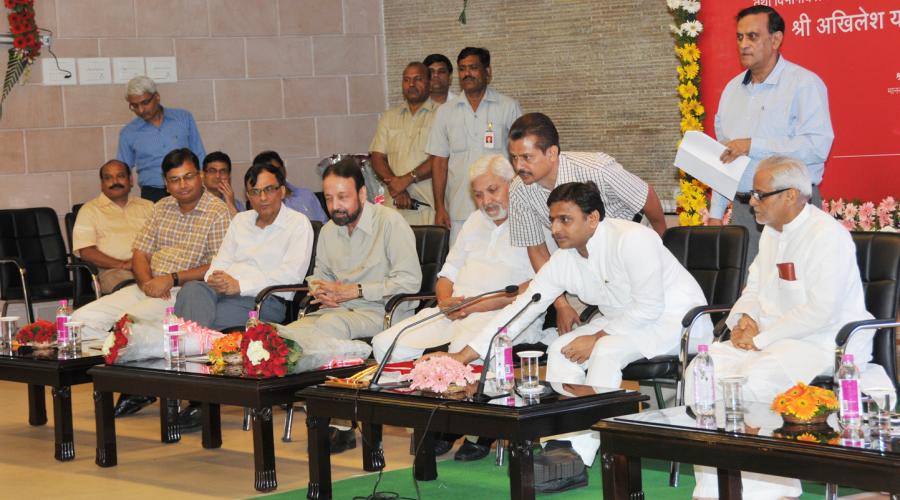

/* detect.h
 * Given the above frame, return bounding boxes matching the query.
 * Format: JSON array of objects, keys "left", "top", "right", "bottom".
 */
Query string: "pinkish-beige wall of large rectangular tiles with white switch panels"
[{"left": 0, "top": 0, "right": 386, "bottom": 215}]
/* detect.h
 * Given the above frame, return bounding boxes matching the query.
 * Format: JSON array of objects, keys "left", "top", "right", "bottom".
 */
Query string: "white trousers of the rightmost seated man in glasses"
[{"left": 685, "top": 339, "right": 834, "bottom": 500}]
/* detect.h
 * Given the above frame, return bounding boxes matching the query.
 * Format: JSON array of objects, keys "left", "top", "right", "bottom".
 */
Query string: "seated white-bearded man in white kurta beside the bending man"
[{"left": 372, "top": 155, "right": 542, "bottom": 363}]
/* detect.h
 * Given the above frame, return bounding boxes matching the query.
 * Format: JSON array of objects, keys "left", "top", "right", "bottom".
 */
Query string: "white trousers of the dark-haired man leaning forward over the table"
[{"left": 547, "top": 324, "right": 644, "bottom": 466}]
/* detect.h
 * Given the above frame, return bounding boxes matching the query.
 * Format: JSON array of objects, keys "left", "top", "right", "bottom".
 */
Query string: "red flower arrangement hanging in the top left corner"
[{"left": 0, "top": 0, "right": 42, "bottom": 116}]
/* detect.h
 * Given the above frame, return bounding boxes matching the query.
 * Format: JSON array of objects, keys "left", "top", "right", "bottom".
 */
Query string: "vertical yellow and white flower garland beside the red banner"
[{"left": 666, "top": 0, "right": 709, "bottom": 226}]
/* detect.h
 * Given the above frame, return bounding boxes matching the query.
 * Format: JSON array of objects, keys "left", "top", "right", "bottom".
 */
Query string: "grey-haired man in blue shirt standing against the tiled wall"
[{"left": 116, "top": 76, "right": 206, "bottom": 202}]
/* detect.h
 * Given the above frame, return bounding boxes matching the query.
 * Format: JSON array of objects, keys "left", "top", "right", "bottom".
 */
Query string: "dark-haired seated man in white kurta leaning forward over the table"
[{"left": 440, "top": 182, "right": 712, "bottom": 492}]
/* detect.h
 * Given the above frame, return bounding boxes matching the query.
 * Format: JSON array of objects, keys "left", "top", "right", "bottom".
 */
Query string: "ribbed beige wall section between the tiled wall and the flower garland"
[{"left": 384, "top": 0, "right": 680, "bottom": 204}]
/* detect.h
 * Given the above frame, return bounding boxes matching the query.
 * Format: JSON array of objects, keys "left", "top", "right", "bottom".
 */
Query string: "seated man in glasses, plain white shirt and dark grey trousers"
[{"left": 175, "top": 163, "right": 313, "bottom": 330}]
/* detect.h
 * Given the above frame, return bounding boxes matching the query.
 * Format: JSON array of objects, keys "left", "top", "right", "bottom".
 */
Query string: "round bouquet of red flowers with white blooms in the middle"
[{"left": 241, "top": 323, "right": 302, "bottom": 377}]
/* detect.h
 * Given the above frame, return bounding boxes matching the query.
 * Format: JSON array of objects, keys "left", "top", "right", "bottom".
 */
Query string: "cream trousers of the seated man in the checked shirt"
[{"left": 72, "top": 285, "right": 181, "bottom": 340}]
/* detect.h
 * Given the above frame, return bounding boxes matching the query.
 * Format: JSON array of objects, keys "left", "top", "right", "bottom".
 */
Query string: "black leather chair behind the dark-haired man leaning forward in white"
[{"left": 581, "top": 226, "right": 749, "bottom": 408}]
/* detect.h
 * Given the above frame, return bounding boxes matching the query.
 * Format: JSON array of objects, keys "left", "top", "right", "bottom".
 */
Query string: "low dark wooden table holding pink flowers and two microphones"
[{"left": 297, "top": 384, "right": 648, "bottom": 499}]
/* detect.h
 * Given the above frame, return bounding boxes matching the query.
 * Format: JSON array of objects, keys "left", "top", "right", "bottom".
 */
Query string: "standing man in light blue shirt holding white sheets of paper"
[{"left": 709, "top": 5, "right": 834, "bottom": 259}]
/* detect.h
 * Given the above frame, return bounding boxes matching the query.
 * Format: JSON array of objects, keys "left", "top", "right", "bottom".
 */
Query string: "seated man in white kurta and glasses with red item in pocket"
[{"left": 685, "top": 156, "right": 876, "bottom": 500}]
